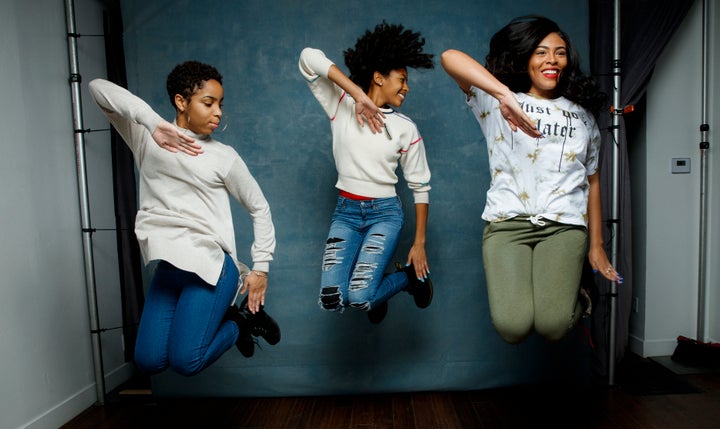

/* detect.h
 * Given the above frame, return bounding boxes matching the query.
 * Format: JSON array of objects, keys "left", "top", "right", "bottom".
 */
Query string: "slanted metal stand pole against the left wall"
[{"left": 65, "top": 0, "right": 105, "bottom": 405}]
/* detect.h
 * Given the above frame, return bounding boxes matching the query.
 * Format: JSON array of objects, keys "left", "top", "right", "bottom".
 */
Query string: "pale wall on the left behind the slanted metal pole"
[{"left": 0, "top": 0, "right": 129, "bottom": 429}]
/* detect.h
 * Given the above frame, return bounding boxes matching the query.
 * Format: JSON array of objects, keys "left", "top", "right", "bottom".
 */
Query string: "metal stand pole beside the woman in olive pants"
[{"left": 608, "top": 0, "right": 623, "bottom": 386}]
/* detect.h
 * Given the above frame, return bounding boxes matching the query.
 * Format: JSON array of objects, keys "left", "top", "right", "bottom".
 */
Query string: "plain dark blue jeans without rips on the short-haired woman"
[{"left": 135, "top": 254, "right": 239, "bottom": 376}]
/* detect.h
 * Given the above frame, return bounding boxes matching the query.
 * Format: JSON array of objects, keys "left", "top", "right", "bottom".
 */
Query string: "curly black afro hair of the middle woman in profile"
[{"left": 343, "top": 21, "right": 434, "bottom": 92}]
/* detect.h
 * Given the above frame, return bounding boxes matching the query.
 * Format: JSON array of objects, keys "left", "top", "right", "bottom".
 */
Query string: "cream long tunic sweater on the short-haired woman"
[{"left": 90, "top": 79, "right": 275, "bottom": 285}]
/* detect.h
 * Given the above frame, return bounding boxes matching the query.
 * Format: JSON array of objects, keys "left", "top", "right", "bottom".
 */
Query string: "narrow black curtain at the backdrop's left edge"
[{"left": 103, "top": 0, "right": 144, "bottom": 361}]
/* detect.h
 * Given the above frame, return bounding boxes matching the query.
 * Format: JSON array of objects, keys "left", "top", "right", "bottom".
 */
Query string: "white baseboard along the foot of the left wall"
[{"left": 18, "top": 363, "right": 135, "bottom": 429}]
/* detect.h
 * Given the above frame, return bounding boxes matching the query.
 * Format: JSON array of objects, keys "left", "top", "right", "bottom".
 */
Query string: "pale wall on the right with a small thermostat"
[{"left": 630, "top": 0, "right": 720, "bottom": 356}]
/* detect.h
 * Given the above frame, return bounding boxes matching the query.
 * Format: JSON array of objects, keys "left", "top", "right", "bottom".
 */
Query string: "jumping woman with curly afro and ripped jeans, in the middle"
[{"left": 299, "top": 22, "right": 433, "bottom": 323}]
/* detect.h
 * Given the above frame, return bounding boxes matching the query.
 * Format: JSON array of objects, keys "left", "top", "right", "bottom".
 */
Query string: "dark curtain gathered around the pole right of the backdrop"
[{"left": 589, "top": 0, "right": 693, "bottom": 375}]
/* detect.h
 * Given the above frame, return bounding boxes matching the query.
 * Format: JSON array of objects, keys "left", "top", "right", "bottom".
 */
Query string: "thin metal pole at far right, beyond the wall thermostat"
[{"left": 696, "top": 0, "right": 710, "bottom": 342}]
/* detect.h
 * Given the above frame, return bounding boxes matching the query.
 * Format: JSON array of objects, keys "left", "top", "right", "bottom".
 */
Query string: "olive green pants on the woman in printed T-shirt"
[{"left": 483, "top": 219, "right": 587, "bottom": 344}]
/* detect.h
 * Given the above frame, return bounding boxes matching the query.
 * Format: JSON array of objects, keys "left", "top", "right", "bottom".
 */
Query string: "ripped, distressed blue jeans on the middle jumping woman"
[{"left": 319, "top": 196, "right": 408, "bottom": 311}]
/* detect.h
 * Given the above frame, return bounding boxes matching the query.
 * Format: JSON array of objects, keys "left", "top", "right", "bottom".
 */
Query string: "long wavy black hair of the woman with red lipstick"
[{"left": 485, "top": 15, "right": 607, "bottom": 116}]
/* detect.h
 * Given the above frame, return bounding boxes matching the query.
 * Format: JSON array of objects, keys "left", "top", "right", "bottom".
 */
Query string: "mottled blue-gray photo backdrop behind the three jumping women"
[{"left": 121, "top": 0, "right": 590, "bottom": 396}]
